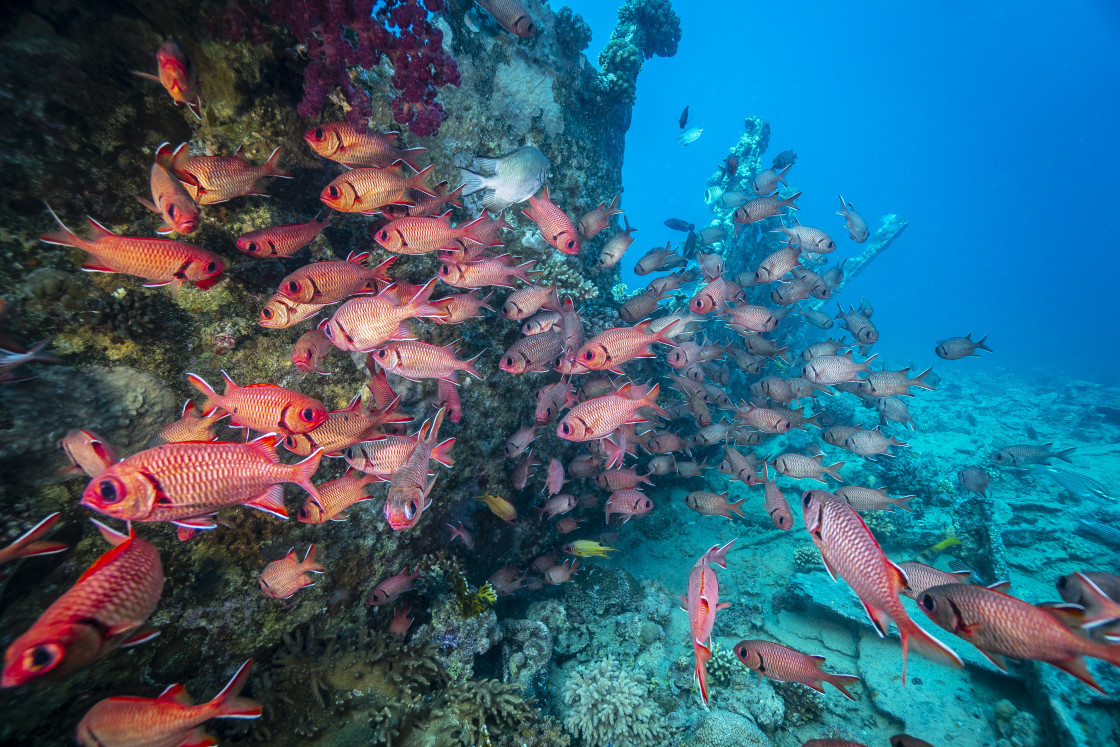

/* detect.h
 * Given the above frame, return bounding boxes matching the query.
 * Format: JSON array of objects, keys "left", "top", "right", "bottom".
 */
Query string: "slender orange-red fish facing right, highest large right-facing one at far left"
[{"left": 39, "top": 205, "right": 225, "bottom": 293}]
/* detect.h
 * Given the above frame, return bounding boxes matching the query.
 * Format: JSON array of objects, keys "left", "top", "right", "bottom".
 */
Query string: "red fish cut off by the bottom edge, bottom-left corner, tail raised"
[{"left": 75, "top": 659, "right": 261, "bottom": 747}]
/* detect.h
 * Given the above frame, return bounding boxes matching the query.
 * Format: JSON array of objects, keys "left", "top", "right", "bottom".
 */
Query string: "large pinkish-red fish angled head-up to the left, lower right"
[{"left": 801, "top": 491, "right": 963, "bottom": 688}]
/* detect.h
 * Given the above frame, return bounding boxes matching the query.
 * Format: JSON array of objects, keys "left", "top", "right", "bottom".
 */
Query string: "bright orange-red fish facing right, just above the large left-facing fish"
[{"left": 187, "top": 371, "right": 327, "bottom": 435}]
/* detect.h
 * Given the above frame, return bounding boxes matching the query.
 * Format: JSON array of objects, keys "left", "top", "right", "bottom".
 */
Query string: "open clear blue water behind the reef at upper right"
[{"left": 569, "top": 0, "right": 1120, "bottom": 383}]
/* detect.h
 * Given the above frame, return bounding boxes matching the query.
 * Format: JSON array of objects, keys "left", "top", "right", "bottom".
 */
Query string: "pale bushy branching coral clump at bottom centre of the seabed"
[{"left": 563, "top": 659, "right": 669, "bottom": 747}]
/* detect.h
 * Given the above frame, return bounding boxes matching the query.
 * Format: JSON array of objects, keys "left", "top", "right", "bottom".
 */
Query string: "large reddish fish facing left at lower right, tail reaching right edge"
[{"left": 917, "top": 583, "right": 1120, "bottom": 694}]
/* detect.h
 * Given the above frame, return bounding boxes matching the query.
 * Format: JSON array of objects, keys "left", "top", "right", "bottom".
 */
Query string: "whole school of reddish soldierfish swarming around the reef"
[{"left": 0, "top": 32, "right": 1120, "bottom": 747}]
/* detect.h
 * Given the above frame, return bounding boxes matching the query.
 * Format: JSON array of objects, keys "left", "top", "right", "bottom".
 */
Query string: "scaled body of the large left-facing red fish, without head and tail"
[{"left": 94, "top": 442, "right": 306, "bottom": 522}]
